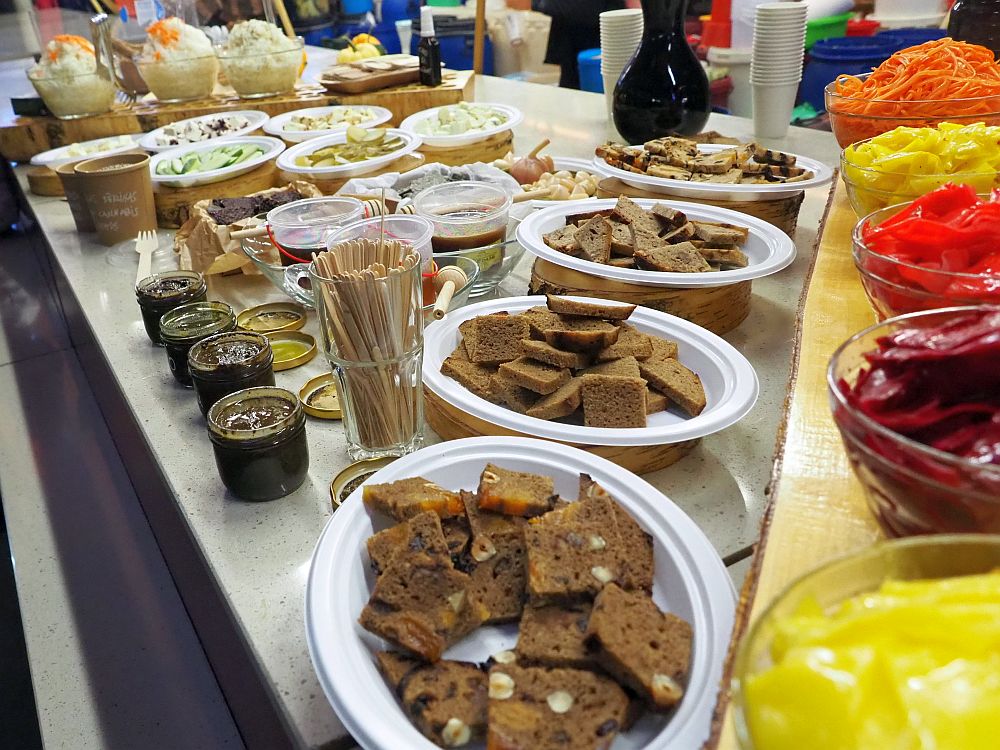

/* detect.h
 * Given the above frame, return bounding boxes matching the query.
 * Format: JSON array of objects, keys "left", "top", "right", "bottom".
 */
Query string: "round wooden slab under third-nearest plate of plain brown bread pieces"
[{"left": 528, "top": 258, "right": 752, "bottom": 335}]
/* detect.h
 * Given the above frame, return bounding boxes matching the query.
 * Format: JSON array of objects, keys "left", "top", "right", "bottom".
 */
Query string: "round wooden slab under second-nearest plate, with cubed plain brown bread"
[{"left": 424, "top": 386, "right": 700, "bottom": 474}]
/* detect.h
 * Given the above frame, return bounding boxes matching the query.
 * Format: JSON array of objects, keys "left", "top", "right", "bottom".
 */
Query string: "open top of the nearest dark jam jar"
[{"left": 208, "top": 385, "right": 305, "bottom": 444}]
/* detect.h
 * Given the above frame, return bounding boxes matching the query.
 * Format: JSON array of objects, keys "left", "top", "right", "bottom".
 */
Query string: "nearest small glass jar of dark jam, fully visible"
[{"left": 208, "top": 386, "right": 309, "bottom": 500}]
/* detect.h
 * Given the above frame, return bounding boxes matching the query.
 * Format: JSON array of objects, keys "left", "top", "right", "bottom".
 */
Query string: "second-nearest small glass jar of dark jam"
[{"left": 188, "top": 331, "right": 274, "bottom": 414}]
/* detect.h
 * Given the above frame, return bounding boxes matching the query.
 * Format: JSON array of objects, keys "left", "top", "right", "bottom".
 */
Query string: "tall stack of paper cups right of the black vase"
[{"left": 750, "top": 2, "right": 808, "bottom": 138}]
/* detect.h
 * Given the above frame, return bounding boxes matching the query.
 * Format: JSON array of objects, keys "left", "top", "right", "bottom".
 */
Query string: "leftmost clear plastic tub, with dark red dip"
[{"left": 267, "top": 196, "right": 365, "bottom": 266}]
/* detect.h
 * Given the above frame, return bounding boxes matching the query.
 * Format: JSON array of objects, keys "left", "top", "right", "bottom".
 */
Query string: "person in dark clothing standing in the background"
[{"left": 531, "top": 0, "right": 625, "bottom": 89}]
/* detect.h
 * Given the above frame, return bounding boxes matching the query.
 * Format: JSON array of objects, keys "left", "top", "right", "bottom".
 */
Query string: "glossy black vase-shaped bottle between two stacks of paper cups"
[{"left": 613, "top": 0, "right": 712, "bottom": 143}]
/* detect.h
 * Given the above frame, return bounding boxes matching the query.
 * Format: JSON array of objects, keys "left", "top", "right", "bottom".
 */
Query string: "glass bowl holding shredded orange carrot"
[{"left": 823, "top": 73, "right": 1000, "bottom": 148}]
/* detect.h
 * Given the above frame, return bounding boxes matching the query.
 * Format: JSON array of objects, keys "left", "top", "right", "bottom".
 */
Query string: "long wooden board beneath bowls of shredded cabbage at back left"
[{"left": 0, "top": 70, "right": 475, "bottom": 162}]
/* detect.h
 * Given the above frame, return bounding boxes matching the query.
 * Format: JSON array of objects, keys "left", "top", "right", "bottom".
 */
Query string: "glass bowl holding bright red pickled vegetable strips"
[{"left": 852, "top": 203, "right": 1000, "bottom": 320}]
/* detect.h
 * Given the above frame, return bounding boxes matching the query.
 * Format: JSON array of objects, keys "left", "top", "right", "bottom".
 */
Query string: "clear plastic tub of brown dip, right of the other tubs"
[{"left": 413, "top": 181, "right": 512, "bottom": 296}]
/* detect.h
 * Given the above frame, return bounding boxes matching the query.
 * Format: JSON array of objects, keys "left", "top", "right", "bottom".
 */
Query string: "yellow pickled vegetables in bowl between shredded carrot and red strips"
[{"left": 844, "top": 122, "right": 1000, "bottom": 213}]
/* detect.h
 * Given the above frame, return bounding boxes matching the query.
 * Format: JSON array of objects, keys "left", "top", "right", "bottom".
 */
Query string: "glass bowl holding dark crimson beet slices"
[{"left": 827, "top": 306, "right": 1000, "bottom": 536}]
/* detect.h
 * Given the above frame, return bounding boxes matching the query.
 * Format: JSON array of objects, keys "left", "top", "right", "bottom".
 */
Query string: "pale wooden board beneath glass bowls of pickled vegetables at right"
[{"left": 707, "top": 178, "right": 882, "bottom": 750}]
